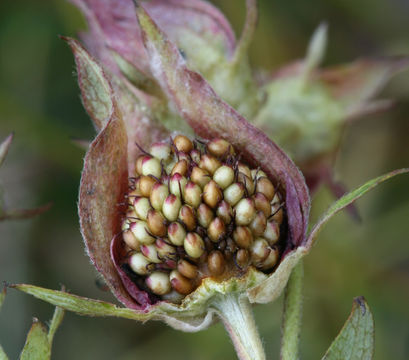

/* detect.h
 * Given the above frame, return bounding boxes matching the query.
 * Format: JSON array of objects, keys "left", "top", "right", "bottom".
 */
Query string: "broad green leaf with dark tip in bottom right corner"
[{"left": 322, "top": 296, "right": 374, "bottom": 360}]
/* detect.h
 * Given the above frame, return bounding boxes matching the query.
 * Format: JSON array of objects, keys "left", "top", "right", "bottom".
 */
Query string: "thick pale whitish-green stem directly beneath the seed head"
[{"left": 213, "top": 293, "right": 266, "bottom": 360}]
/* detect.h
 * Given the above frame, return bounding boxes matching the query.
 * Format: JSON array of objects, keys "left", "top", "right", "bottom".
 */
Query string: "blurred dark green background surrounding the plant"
[{"left": 0, "top": 0, "right": 409, "bottom": 360}]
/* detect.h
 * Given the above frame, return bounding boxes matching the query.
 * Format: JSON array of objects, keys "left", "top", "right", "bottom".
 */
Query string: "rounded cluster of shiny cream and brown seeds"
[{"left": 122, "top": 135, "right": 285, "bottom": 302}]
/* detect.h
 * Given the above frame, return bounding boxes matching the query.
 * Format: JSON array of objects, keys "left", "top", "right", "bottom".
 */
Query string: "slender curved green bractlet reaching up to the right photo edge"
[{"left": 307, "top": 168, "right": 409, "bottom": 247}]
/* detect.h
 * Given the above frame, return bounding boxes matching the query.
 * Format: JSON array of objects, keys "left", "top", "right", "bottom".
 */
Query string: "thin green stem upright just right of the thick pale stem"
[{"left": 280, "top": 261, "right": 304, "bottom": 360}]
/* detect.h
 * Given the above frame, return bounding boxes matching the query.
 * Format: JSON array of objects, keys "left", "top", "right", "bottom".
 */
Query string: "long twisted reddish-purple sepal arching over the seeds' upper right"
[{"left": 137, "top": 6, "right": 310, "bottom": 246}]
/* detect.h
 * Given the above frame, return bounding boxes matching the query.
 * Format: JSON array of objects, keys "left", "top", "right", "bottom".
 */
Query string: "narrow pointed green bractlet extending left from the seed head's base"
[{"left": 10, "top": 284, "right": 152, "bottom": 321}]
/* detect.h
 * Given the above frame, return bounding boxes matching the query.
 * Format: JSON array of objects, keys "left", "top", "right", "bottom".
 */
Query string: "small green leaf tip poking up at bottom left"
[{"left": 20, "top": 318, "right": 51, "bottom": 360}]
